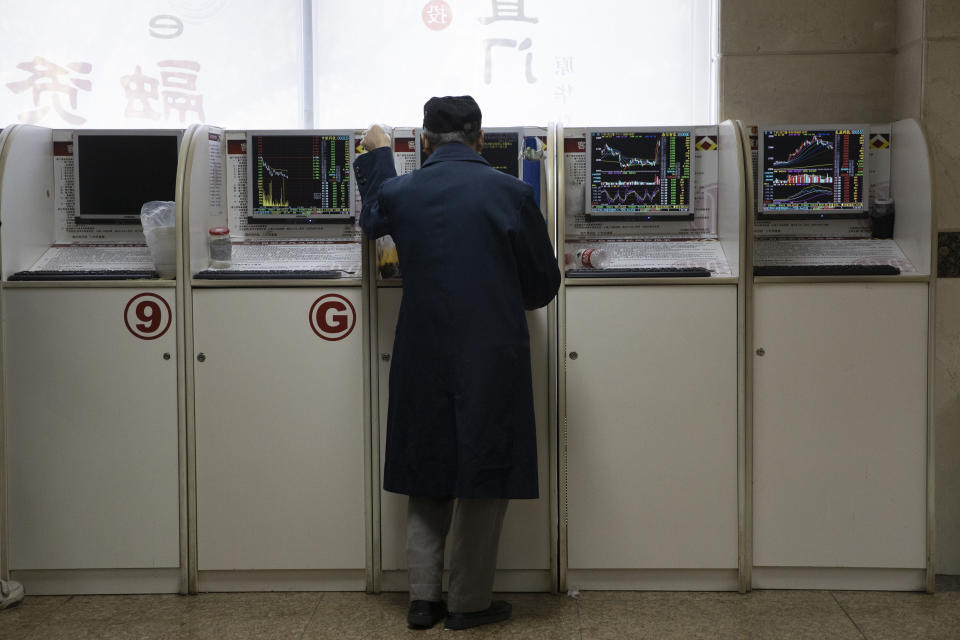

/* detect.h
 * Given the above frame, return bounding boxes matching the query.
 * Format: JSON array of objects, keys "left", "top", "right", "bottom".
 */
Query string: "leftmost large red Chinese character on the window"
[{"left": 7, "top": 56, "right": 93, "bottom": 124}]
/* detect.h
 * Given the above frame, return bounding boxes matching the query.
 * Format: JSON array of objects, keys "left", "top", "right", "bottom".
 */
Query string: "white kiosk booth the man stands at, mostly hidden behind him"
[{"left": 371, "top": 127, "right": 557, "bottom": 591}]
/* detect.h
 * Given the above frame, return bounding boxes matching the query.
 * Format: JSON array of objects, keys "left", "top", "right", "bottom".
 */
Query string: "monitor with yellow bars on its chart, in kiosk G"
[{"left": 247, "top": 130, "right": 354, "bottom": 224}]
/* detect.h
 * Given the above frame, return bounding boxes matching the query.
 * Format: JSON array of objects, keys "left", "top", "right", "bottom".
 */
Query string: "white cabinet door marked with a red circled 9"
[{"left": 4, "top": 287, "right": 180, "bottom": 570}]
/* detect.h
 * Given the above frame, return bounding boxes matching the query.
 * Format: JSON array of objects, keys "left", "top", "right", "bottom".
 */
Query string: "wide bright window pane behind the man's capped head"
[{"left": 314, "top": 0, "right": 715, "bottom": 127}]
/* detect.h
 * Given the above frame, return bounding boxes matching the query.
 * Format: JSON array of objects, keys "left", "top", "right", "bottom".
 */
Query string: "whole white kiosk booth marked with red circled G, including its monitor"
[{"left": 183, "top": 126, "right": 371, "bottom": 592}]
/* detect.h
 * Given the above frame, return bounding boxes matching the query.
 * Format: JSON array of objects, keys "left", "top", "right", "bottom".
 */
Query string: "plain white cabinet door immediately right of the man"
[{"left": 565, "top": 285, "right": 737, "bottom": 569}]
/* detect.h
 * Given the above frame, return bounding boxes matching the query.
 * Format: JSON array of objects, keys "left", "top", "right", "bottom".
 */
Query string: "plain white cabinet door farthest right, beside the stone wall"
[{"left": 749, "top": 283, "right": 927, "bottom": 568}]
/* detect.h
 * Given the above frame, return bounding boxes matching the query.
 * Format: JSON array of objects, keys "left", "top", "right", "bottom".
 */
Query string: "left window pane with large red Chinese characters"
[{"left": 0, "top": 0, "right": 303, "bottom": 128}]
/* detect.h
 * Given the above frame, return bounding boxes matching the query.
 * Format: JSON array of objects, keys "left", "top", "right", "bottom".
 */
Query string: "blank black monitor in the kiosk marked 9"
[{"left": 73, "top": 130, "right": 182, "bottom": 224}]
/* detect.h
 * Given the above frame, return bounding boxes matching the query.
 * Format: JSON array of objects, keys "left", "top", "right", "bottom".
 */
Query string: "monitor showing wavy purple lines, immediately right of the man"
[{"left": 584, "top": 128, "right": 694, "bottom": 221}]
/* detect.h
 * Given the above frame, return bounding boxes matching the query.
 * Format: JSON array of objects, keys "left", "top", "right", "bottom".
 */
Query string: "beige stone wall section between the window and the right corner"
[{"left": 720, "top": 0, "right": 897, "bottom": 124}]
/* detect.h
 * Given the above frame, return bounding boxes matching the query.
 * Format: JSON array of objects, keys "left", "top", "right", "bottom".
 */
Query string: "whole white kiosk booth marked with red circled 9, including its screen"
[{"left": 0, "top": 125, "right": 188, "bottom": 594}]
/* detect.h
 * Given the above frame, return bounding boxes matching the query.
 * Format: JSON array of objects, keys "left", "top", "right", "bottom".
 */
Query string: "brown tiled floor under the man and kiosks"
[{"left": 0, "top": 591, "right": 960, "bottom": 640}]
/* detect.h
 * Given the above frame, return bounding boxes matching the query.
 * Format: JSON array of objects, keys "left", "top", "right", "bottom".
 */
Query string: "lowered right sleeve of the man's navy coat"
[{"left": 512, "top": 193, "right": 560, "bottom": 310}]
